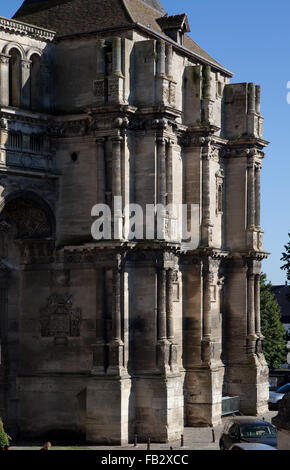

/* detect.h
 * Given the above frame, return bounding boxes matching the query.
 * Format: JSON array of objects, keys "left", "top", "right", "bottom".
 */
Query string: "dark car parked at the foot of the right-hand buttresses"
[{"left": 219, "top": 417, "right": 277, "bottom": 450}]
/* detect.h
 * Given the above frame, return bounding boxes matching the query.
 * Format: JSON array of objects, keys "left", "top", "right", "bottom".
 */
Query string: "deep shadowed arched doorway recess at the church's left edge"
[{"left": 0, "top": 192, "right": 54, "bottom": 437}]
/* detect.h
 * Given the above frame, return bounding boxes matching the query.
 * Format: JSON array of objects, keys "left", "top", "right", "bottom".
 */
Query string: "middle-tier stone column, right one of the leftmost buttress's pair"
[{"left": 112, "top": 136, "right": 123, "bottom": 240}]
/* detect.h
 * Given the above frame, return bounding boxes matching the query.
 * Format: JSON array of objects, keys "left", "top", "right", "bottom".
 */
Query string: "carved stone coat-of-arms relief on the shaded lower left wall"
[{"left": 40, "top": 294, "right": 82, "bottom": 338}]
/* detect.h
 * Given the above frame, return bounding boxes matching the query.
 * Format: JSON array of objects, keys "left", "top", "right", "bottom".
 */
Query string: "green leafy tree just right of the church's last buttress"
[{"left": 261, "top": 274, "right": 287, "bottom": 369}]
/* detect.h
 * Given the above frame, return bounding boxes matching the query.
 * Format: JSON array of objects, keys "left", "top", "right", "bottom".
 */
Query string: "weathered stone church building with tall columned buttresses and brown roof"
[{"left": 0, "top": 0, "right": 268, "bottom": 444}]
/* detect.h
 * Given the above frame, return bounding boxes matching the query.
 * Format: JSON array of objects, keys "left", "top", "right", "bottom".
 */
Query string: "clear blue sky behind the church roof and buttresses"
[{"left": 0, "top": 0, "right": 290, "bottom": 284}]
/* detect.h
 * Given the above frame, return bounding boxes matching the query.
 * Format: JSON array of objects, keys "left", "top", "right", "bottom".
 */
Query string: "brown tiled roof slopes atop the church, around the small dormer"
[{"left": 13, "top": 0, "right": 224, "bottom": 69}]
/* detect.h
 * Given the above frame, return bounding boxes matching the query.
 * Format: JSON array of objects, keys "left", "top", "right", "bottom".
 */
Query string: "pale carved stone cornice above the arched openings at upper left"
[{"left": 0, "top": 16, "right": 55, "bottom": 42}]
